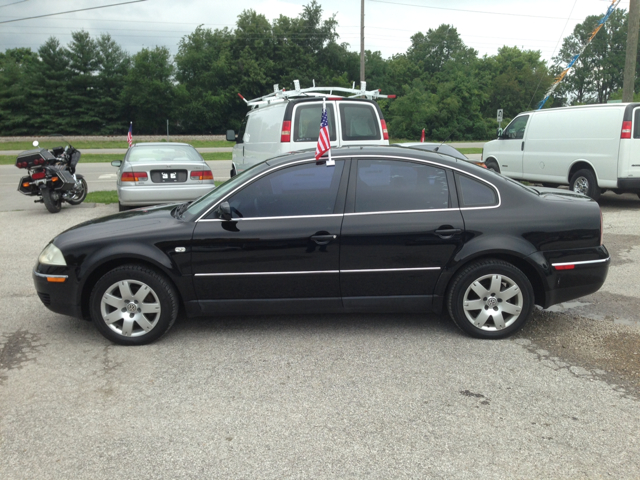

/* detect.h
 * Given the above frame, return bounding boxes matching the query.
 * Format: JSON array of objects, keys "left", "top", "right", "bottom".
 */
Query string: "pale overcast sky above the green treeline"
[{"left": 0, "top": 0, "right": 629, "bottom": 69}]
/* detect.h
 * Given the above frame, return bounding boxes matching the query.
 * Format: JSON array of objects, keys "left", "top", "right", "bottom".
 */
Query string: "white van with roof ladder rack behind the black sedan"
[{"left": 227, "top": 80, "right": 395, "bottom": 176}]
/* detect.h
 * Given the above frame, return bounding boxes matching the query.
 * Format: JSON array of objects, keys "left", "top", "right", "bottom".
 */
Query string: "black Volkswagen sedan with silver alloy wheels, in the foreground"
[{"left": 33, "top": 146, "right": 610, "bottom": 345}]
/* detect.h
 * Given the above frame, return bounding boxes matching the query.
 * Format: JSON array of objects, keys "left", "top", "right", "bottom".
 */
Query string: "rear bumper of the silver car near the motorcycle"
[{"left": 118, "top": 182, "right": 215, "bottom": 206}]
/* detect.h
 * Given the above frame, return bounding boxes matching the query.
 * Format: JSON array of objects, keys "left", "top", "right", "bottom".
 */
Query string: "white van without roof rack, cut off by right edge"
[{"left": 482, "top": 103, "right": 640, "bottom": 199}]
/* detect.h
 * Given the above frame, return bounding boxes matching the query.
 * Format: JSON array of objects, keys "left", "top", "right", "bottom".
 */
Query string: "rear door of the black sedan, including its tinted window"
[{"left": 340, "top": 158, "right": 464, "bottom": 311}]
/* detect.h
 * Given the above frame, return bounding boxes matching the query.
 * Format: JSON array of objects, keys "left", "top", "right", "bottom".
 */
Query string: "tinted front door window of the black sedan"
[{"left": 229, "top": 160, "right": 344, "bottom": 218}]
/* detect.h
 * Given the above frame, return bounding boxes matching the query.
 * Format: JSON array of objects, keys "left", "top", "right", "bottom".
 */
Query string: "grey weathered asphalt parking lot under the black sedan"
[{"left": 0, "top": 162, "right": 640, "bottom": 479}]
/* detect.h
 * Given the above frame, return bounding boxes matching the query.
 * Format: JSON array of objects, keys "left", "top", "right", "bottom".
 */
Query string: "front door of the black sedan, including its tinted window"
[{"left": 192, "top": 159, "right": 346, "bottom": 313}]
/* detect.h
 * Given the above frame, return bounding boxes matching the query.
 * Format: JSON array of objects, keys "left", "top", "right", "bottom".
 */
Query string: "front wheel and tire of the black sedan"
[{"left": 89, "top": 265, "right": 178, "bottom": 345}]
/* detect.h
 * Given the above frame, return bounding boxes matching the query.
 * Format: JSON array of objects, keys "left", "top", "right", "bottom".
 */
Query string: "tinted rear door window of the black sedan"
[{"left": 355, "top": 160, "right": 449, "bottom": 212}]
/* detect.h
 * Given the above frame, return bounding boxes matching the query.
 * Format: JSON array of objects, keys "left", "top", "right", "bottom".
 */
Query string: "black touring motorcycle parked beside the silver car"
[{"left": 16, "top": 140, "right": 88, "bottom": 213}]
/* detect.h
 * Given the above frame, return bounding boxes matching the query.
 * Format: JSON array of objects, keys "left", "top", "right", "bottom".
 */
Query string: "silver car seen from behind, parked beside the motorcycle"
[{"left": 111, "top": 142, "right": 215, "bottom": 211}]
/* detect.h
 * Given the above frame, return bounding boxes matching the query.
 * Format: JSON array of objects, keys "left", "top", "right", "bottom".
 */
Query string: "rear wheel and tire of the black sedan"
[{"left": 447, "top": 260, "right": 534, "bottom": 339}]
